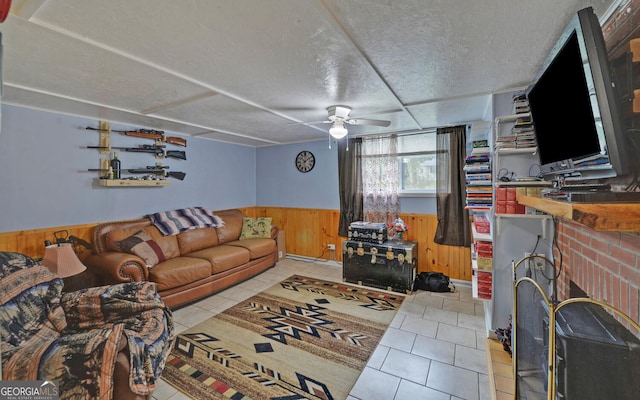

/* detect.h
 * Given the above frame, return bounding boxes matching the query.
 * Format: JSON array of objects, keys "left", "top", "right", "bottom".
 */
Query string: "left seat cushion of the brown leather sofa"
[{"left": 149, "top": 257, "right": 211, "bottom": 291}]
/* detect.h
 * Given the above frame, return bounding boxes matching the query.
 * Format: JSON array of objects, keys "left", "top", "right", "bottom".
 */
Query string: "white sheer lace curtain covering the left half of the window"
[{"left": 362, "top": 135, "right": 400, "bottom": 225}]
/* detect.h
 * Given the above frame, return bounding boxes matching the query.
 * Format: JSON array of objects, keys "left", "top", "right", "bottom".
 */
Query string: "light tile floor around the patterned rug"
[{"left": 153, "top": 258, "right": 492, "bottom": 400}]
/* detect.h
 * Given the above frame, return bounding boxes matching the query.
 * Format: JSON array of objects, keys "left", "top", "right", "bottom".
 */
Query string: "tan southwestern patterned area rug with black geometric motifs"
[{"left": 162, "top": 275, "right": 404, "bottom": 400}]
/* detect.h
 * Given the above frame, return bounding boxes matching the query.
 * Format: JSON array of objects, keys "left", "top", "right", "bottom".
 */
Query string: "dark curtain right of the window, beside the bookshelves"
[{"left": 433, "top": 125, "right": 471, "bottom": 247}]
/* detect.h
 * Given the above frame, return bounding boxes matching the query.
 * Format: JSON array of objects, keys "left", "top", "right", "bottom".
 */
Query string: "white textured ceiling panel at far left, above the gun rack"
[{"left": 3, "top": 18, "right": 212, "bottom": 112}]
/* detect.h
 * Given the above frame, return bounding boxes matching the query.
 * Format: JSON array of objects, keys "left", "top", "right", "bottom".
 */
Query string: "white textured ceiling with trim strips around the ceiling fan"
[{"left": 0, "top": 0, "right": 616, "bottom": 147}]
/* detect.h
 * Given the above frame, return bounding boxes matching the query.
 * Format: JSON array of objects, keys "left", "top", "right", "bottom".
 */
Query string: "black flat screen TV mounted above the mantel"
[{"left": 527, "top": 7, "right": 630, "bottom": 181}]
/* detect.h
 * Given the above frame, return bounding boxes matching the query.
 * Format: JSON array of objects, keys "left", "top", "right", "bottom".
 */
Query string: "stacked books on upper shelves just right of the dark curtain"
[{"left": 464, "top": 140, "right": 492, "bottom": 209}]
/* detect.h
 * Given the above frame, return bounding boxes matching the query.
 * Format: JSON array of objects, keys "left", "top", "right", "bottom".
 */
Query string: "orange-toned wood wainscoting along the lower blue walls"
[{"left": 0, "top": 207, "right": 471, "bottom": 281}]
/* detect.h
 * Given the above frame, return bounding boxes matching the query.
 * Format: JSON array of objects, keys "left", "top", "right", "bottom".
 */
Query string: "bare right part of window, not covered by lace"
[{"left": 398, "top": 130, "right": 436, "bottom": 195}]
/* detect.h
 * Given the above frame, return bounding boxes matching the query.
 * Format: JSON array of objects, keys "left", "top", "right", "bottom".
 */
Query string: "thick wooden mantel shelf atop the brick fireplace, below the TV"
[{"left": 517, "top": 195, "right": 640, "bottom": 232}]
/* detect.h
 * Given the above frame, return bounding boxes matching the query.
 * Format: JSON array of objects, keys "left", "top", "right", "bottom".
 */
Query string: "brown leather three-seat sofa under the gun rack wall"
[{"left": 83, "top": 209, "right": 278, "bottom": 308}]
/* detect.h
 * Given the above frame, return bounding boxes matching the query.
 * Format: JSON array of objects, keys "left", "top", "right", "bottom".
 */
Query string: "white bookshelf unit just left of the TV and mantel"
[{"left": 478, "top": 93, "right": 553, "bottom": 335}]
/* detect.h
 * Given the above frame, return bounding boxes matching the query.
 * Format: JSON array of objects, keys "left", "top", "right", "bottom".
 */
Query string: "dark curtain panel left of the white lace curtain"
[{"left": 338, "top": 138, "right": 363, "bottom": 237}]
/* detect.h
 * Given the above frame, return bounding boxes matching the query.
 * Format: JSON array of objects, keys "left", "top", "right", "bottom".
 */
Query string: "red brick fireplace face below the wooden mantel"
[{"left": 553, "top": 219, "right": 640, "bottom": 322}]
